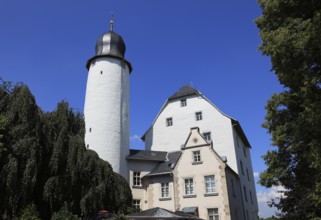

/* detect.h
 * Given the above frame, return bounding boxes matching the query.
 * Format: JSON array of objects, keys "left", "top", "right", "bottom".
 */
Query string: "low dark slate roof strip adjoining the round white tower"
[{"left": 126, "top": 150, "right": 167, "bottom": 162}]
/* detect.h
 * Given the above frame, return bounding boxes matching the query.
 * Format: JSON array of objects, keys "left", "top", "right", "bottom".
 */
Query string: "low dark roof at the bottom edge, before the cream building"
[{"left": 128, "top": 207, "right": 200, "bottom": 219}]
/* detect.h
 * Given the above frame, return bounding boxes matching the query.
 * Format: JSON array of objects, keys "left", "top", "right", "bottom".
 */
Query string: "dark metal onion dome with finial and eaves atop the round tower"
[{"left": 86, "top": 20, "right": 132, "bottom": 72}]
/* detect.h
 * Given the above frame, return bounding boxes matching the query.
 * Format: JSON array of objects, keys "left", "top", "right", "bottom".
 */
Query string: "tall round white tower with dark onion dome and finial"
[{"left": 84, "top": 20, "right": 132, "bottom": 179}]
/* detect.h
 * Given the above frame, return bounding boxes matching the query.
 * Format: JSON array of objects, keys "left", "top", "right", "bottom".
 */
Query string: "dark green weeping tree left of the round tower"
[{"left": 0, "top": 83, "right": 132, "bottom": 219}]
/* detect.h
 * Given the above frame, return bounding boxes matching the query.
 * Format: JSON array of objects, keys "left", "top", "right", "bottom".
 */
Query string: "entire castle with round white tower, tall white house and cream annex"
[{"left": 84, "top": 20, "right": 258, "bottom": 220}]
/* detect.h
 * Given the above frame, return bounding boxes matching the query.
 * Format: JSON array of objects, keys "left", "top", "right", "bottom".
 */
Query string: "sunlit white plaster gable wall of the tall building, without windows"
[{"left": 145, "top": 96, "right": 238, "bottom": 173}]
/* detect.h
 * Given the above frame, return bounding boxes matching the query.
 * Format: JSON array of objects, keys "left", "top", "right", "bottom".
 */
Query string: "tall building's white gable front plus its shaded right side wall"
[{"left": 143, "top": 87, "right": 258, "bottom": 219}]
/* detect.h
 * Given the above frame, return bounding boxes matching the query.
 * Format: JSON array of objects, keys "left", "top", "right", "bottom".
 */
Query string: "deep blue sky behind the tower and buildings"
[{"left": 0, "top": 0, "right": 282, "bottom": 217}]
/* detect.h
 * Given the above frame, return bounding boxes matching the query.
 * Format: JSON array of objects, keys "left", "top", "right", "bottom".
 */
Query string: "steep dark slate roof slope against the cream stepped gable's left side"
[{"left": 146, "top": 151, "right": 181, "bottom": 176}]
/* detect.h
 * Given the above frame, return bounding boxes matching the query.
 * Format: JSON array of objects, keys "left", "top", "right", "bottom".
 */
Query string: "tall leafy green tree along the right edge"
[{"left": 256, "top": 0, "right": 321, "bottom": 219}]
